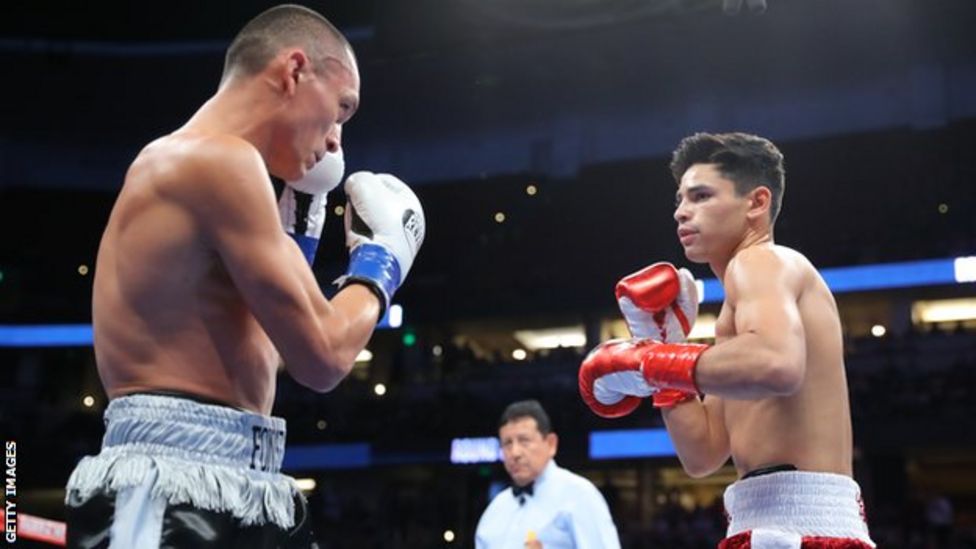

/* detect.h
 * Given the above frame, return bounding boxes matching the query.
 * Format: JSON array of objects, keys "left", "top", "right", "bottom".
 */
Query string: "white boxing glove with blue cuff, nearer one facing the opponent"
[{"left": 338, "top": 172, "right": 426, "bottom": 318}]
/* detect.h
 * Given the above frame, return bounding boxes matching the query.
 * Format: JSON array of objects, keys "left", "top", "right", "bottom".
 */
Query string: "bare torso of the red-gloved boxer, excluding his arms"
[{"left": 716, "top": 246, "right": 852, "bottom": 475}]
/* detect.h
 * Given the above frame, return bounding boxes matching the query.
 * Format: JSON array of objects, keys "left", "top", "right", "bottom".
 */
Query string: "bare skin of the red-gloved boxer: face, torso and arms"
[{"left": 664, "top": 164, "right": 853, "bottom": 477}]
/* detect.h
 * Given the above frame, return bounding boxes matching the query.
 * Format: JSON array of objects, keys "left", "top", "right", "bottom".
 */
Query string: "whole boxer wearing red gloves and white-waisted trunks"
[{"left": 579, "top": 133, "right": 874, "bottom": 549}]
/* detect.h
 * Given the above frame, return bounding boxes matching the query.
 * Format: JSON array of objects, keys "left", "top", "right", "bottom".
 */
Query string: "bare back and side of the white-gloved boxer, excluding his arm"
[{"left": 92, "top": 133, "right": 278, "bottom": 413}]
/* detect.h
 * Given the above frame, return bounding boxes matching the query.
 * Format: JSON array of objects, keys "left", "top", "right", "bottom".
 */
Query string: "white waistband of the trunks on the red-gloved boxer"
[{"left": 725, "top": 471, "right": 874, "bottom": 546}]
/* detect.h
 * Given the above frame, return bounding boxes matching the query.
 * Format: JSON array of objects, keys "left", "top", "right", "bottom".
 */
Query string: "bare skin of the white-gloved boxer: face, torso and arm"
[{"left": 92, "top": 42, "right": 379, "bottom": 414}]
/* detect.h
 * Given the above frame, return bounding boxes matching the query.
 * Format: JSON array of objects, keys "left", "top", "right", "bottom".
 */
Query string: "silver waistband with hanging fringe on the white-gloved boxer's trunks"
[{"left": 65, "top": 395, "right": 298, "bottom": 529}]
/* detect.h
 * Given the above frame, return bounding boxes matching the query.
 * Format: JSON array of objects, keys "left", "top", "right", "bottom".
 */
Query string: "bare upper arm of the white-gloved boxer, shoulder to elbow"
[{"left": 188, "top": 143, "right": 345, "bottom": 390}]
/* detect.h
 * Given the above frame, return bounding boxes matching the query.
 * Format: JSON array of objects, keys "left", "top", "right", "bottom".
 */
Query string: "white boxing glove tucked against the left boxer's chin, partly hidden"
[{"left": 278, "top": 149, "right": 346, "bottom": 265}]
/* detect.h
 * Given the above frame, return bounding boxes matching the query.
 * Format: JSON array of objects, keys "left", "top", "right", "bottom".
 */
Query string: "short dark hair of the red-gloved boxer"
[{"left": 671, "top": 132, "right": 786, "bottom": 224}]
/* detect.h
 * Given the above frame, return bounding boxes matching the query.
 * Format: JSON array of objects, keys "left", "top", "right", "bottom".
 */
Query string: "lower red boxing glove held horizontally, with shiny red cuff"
[{"left": 579, "top": 339, "right": 708, "bottom": 418}]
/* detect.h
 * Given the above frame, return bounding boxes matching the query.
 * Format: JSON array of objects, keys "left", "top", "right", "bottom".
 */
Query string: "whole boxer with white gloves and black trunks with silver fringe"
[{"left": 66, "top": 5, "right": 425, "bottom": 549}]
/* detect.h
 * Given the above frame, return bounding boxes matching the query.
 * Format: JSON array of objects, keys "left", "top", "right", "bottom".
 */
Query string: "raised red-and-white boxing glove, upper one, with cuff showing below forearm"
[{"left": 615, "top": 262, "right": 698, "bottom": 408}]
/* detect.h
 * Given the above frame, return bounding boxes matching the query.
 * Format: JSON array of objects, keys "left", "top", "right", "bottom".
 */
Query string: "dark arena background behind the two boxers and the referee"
[{"left": 0, "top": 0, "right": 976, "bottom": 547}]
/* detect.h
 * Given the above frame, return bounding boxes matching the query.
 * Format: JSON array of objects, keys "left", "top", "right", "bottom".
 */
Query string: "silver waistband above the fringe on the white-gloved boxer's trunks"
[{"left": 102, "top": 395, "right": 285, "bottom": 473}]
